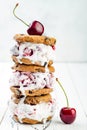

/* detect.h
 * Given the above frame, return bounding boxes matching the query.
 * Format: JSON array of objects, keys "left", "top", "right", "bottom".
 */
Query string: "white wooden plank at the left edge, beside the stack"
[{"left": 0, "top": 63, "right": 11, "bottom": 125}]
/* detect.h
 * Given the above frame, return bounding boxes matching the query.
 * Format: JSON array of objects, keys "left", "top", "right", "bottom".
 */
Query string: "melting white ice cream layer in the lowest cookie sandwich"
[{"left": 9, "top": 99, "right": 56, "bottom": 122}]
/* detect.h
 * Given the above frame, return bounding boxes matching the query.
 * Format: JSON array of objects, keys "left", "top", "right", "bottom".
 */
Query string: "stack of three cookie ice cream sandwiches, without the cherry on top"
[{"left": 10, "top": 34, "right": 56, "bottom": 124}]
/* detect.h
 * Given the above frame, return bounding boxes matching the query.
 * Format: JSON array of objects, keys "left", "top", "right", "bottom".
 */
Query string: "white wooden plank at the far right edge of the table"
[{"left": 69, "top": 63, "right": 87, "bottom": 116}]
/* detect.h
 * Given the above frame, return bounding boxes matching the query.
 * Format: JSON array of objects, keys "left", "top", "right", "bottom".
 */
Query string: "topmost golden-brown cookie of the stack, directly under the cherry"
[{"left": 14, "top": 34, "right": 56, "bottom": 46}]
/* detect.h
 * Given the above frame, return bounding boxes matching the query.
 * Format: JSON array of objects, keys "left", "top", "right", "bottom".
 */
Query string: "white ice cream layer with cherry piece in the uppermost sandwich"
[{"left": 11, "top": 42, "right": 55, "bottom": 66}]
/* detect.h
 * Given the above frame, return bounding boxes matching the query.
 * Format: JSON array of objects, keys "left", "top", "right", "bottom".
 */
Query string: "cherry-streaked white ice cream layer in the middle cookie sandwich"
[{"left": 10, "top": 71, "right": 56, "bottom": 91}]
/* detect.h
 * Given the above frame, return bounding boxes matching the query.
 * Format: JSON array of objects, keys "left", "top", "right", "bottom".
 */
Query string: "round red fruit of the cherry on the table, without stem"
[{"left": 60, "top": 107, "right": 76, "bottom": 124}]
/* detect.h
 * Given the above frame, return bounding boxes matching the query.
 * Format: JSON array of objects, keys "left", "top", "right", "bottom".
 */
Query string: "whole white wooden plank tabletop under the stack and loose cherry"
[{"left": 0, "top": 63, "right": 87, "bottom": 130}]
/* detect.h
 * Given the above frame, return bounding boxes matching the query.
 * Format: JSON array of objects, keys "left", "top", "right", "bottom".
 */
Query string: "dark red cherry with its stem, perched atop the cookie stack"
[{"left": 13, "top": 3, "right": 44, "bottom": 35}]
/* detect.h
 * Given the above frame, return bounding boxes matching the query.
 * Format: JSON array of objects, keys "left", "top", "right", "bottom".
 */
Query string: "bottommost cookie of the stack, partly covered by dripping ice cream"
[{"left": 13, "top": 115, "right": 52, "bottom": 125}]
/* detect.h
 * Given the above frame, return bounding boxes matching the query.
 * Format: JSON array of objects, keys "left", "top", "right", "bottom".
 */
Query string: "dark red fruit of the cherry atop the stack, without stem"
[{"left": 27, "top": 21, "right": 44, "bottom": 35}]
